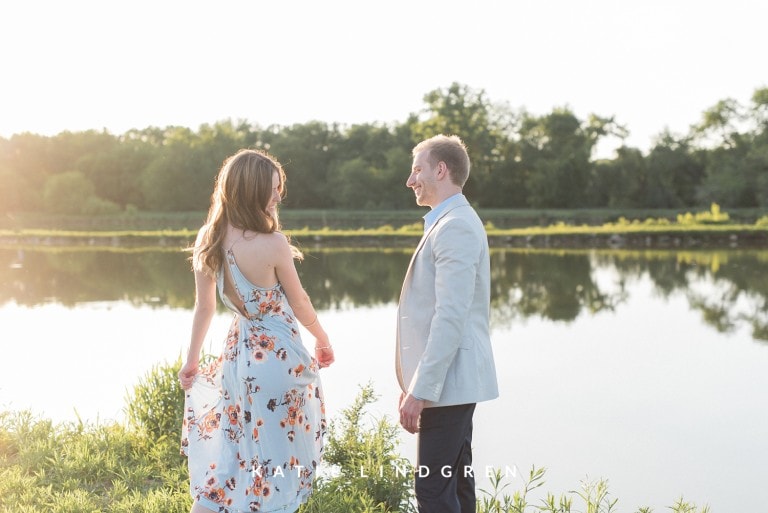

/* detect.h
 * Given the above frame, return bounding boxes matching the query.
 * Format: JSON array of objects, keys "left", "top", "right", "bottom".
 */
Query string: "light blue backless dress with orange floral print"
[{"left": 182, "top": 250, "right": 326, "bottom": 513}]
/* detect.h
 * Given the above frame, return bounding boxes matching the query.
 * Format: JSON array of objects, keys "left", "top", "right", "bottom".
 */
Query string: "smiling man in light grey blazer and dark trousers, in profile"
[{"left": 396, "top": 135, "right": 499, "bottom": 513}]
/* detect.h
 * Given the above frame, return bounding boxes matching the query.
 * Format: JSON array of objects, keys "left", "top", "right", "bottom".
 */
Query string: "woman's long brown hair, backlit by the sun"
[{"left": 191, "top": 150, "right": 301, "bottom": 276}]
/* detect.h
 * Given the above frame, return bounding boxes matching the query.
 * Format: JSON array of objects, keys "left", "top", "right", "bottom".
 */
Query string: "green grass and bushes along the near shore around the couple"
[{"left": 0, "top": 362, "right": 708, "bottom": 513}]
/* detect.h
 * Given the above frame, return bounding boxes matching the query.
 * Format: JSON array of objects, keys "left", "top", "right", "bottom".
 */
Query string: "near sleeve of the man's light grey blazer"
[{"left": 409, "top": 218, "right": 483, "bottom": 401}]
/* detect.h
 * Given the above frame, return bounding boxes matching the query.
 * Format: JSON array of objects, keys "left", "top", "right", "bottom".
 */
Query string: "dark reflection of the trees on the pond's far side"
[{"left": 0, "top": 248, "right": 768, "bottom": 341}]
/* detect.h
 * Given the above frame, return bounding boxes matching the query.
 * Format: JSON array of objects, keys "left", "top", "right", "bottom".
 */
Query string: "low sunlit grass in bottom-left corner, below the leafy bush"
[{"left": 0, "top": 412, "right": 191, "bottom": 513}]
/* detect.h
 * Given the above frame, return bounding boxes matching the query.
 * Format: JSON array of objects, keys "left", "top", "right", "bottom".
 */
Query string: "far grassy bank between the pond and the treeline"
[{"left": 0, "top": 205, "right": 768, "bottom": 247}]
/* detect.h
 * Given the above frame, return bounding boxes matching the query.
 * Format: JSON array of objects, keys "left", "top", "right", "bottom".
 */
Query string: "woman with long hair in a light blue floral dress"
[{"left": 179, "top": 150, "right": 334, "bottom": 513}]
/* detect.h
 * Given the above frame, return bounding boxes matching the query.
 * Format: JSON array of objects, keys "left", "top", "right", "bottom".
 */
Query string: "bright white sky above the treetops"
[{"left": 0, "top": 0, "right": 768, "bottom": 150}]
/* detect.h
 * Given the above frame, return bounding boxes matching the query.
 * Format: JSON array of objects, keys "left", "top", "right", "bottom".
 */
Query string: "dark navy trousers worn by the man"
[{"left": 416, "top": 403, "right": 476, "bottom": 513}]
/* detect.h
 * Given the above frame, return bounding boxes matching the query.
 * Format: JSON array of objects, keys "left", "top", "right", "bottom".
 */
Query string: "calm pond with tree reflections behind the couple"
[{"left": 0, "top": 248, "right": 768, "bottom": 512}]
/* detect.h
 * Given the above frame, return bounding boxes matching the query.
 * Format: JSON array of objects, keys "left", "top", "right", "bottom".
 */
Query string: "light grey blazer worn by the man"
[{"left": 395, "top": 195, "right": 499, "bottom": 407}]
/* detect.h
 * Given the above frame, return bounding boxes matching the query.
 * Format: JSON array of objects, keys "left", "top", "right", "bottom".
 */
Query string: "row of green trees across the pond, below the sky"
[{"left": 0, "top": 83, "right": 768, "bottom": 215}]
